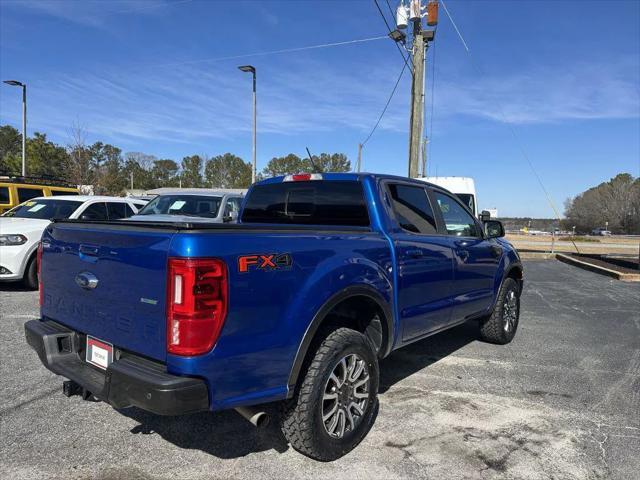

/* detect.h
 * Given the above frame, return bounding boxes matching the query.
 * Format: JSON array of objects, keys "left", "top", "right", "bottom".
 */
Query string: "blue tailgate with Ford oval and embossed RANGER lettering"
[{"left": 41, "top": 223, "right": 175, "bottom": 361}]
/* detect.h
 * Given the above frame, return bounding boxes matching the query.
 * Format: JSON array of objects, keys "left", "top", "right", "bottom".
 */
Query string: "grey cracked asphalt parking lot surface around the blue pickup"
[{"left": 0, "top": 261, "right": 640, "bottom": 480}]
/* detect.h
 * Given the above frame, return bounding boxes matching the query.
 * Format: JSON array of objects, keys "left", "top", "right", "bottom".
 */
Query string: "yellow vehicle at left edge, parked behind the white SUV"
[{"left": 0, "top": 176, "right": 78, "bottom": 214}]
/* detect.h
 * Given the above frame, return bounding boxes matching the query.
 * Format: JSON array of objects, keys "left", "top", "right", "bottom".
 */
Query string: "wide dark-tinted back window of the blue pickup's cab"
[{"left": 242, "top": 180, "right": 369, "bottom": 227}]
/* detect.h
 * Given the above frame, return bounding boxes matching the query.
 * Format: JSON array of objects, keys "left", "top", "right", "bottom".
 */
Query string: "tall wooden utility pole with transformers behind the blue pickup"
[{"left": 399, "top": 0, "right": 438, "bottom": 178}]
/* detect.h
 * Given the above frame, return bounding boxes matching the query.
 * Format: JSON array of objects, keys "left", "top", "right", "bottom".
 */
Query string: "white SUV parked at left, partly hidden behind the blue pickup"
[{"left": 0, "top": 195, "right": 146, "bottom": 289}]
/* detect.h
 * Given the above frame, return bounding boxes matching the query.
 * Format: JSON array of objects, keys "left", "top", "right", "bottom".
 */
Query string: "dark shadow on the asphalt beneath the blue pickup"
[{"left": 120, "top": 322, "right": 478, "bottom": 459}]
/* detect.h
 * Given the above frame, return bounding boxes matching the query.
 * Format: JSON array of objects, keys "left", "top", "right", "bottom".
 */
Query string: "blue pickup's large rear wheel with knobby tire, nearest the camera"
[{"left": 281, "top": 328, "right": 379, "bottom": 462}]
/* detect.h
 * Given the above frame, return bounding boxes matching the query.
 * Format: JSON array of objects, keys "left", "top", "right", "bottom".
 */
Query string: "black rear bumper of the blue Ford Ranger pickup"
[{"left": 24, "top": 320, "right": 209, "bottom": 415}]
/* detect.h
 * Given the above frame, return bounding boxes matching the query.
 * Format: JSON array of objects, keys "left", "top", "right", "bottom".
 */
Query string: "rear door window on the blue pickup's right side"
[{"left": 389, "top": 184, "right": 438, "bottom": 234}]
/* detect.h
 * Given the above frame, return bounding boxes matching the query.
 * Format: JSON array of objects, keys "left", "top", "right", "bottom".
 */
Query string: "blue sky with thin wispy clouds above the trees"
[{"left": 0, "top": 0, "right": 640, "bottom": 217}]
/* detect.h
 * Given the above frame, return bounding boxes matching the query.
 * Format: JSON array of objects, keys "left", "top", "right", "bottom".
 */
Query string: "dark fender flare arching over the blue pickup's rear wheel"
[{"left": 287, "top": 285, "right": 394, "bottom": 398}]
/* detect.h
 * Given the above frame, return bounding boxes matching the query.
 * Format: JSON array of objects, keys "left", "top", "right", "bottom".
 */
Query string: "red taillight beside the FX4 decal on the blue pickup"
[{"left": 167, "top": 258, "right": 228, "bottom": 356}]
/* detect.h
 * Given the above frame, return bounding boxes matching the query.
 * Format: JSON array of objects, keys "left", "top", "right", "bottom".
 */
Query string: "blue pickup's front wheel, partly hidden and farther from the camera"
[{"left": 480, "top": 277, "right": 520, "bottom": 345}]
